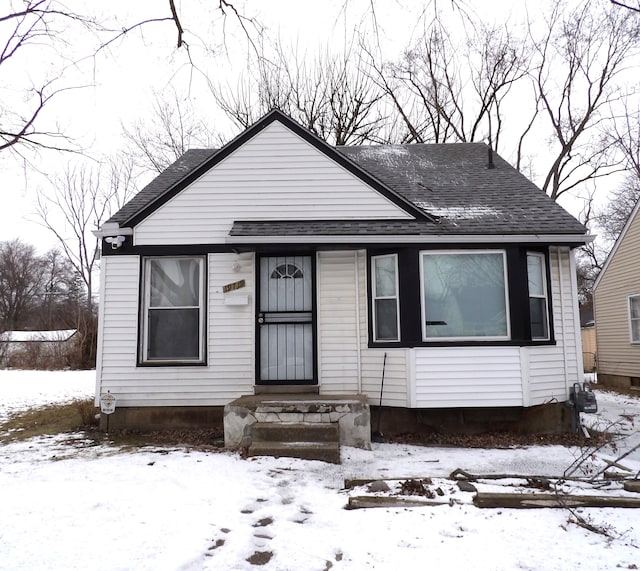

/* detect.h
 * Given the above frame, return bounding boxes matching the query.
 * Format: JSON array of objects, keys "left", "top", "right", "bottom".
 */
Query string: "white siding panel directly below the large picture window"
[{"left": 415, "top": 347, "right": 523, "bottom": 408}]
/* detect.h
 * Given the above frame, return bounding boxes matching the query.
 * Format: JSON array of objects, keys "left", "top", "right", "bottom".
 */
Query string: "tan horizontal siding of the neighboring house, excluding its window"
[{"left": 593, "top": 209, "right": 640, "bottom": 377}]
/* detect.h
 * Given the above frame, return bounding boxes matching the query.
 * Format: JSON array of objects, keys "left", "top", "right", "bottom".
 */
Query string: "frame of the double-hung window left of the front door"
[{"left": 138, "top": 255, "right": 208, "bottom": 366}]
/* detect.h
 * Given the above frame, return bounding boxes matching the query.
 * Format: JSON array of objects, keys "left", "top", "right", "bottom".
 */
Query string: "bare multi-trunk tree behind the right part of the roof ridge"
[{"left": 369, "top": 14, "right": 529, "bottom": 147}]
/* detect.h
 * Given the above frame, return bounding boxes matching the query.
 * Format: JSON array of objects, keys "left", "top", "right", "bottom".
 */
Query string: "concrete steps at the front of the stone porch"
[{"left": 248, "top": 422, "right": 340, "bottom": 464}]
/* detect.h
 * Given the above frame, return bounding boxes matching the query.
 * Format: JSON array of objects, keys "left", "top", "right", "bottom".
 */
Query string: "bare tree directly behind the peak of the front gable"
[{"left": 211, "top": 40, "right": 386, "bottom": 145}]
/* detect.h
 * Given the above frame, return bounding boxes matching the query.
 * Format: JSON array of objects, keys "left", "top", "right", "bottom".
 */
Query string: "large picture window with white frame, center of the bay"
[{"left": 420, "top": 251, "right": 510, "bottom": 341}]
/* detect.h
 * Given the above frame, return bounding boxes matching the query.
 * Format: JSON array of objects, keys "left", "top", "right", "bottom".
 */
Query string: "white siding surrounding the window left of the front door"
[{"left": 99, "top": 254, "right": 254, "bottom": 406}]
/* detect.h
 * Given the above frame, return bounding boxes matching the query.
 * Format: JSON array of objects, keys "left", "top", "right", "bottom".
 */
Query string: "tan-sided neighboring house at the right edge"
[{"left": 593, "top": 202, "right": 640, "bottom": 388}]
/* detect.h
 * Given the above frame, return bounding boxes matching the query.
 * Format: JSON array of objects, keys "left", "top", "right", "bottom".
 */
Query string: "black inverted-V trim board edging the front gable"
[{"left": 120, "top": 109, "right": 436, "bottom": 228}]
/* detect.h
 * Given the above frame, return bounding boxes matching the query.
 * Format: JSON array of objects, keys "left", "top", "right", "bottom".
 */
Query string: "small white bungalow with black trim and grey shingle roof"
[{"left": 97, "top": 111, "right": 589, "bottom": 452}]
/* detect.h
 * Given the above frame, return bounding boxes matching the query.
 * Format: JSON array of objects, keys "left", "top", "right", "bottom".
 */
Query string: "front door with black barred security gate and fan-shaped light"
[{"left": 257, "top": 256, "right": 316, "bottom": 385}]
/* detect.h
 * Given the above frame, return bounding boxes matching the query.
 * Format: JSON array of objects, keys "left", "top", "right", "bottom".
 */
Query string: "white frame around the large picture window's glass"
[{"left": 418, "top": 249, "right": 511, "bottom": 343}]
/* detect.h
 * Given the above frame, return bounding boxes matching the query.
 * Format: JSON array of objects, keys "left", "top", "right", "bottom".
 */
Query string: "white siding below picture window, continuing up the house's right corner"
[{"left": 415, "top": 248, "right": 582, "bottom": 408}]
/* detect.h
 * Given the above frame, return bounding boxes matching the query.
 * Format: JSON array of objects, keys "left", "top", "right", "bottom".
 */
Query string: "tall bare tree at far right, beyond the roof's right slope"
[{"left": 531, "top": 0, "right": 640, "bottom": 200}]
